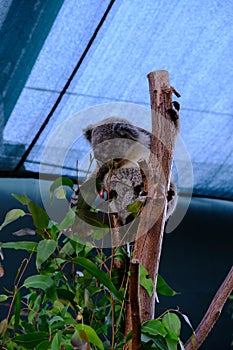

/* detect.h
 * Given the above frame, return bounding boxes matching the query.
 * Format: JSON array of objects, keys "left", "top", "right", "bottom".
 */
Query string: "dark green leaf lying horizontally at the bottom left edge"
[{"left": 12, "top": 332, "right": 49, "bottom": 349}]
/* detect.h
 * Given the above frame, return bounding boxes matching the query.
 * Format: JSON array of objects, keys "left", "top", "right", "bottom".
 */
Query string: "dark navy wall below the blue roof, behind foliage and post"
[{"left": 0, "top": 179, "right": 233, "bottom": 350}]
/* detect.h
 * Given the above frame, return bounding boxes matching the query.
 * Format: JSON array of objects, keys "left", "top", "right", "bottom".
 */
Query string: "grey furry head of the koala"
[{"left": 83, "top": 117, "right": 151, "bottom": 162}]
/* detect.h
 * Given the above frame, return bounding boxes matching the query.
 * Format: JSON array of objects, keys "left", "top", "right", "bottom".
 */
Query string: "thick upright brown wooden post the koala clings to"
[{"left": 133, "top": 70, "right": 177, "bottom": 322}]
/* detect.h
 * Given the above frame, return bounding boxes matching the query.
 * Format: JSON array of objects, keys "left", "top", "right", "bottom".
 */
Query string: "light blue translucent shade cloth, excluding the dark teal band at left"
[{"left": 0, "top": 0, "right": 233, "bottom": 199}]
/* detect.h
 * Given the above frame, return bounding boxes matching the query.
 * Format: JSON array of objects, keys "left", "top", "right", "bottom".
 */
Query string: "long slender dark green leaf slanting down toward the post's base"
[{"left": 72, "top": 258, "right": 122, "bottom": 300}]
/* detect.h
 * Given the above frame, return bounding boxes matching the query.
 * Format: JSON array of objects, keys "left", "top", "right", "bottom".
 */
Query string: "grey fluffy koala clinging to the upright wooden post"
[{"left": 83, "top": 113, "right": 179, "bottom": 224}]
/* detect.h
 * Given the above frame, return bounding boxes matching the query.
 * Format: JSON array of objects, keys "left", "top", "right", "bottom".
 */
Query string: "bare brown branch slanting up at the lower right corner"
[{"left": 185, "top": 267, "right": 233, "bottom": 350}]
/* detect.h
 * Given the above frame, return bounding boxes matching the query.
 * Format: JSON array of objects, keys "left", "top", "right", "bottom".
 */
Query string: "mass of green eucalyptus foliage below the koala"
[{"left": 0, "top": 178, "right": 189, "bottom": 350}]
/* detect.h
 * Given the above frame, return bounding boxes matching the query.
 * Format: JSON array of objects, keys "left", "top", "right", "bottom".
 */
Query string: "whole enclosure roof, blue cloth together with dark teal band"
[{"left": 0, "top": 0, "right": 233, "bottom": 199}]
